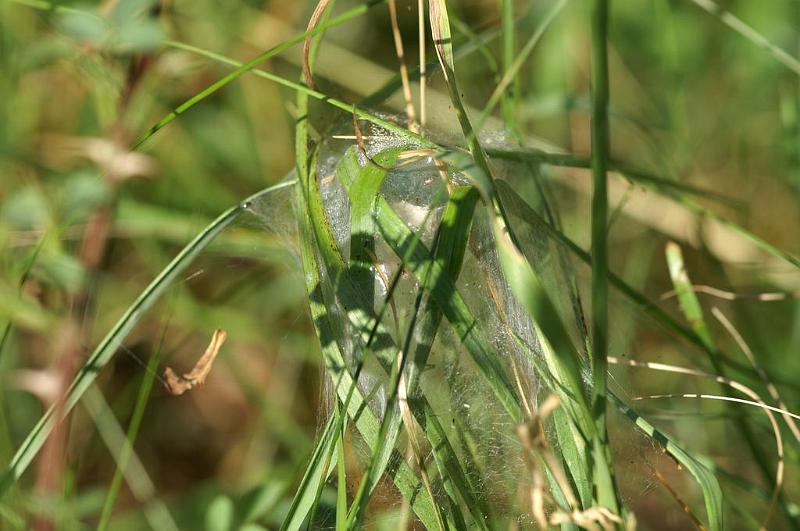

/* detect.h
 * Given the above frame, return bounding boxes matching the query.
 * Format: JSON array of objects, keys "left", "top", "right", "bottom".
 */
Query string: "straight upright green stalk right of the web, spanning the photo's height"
[{"left": 591, "top": 0, "right": 619, "bottom": 513}]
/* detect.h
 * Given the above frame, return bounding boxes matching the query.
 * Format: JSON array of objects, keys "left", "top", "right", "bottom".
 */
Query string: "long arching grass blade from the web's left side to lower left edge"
[{"left": 0, "top": 182, "right": 293, "bottom": 498}]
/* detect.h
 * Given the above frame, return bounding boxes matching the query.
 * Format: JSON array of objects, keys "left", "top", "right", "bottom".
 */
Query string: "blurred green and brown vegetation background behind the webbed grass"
[{"left": 0, "top": 0, "right": 800, "bottom": 529}]
